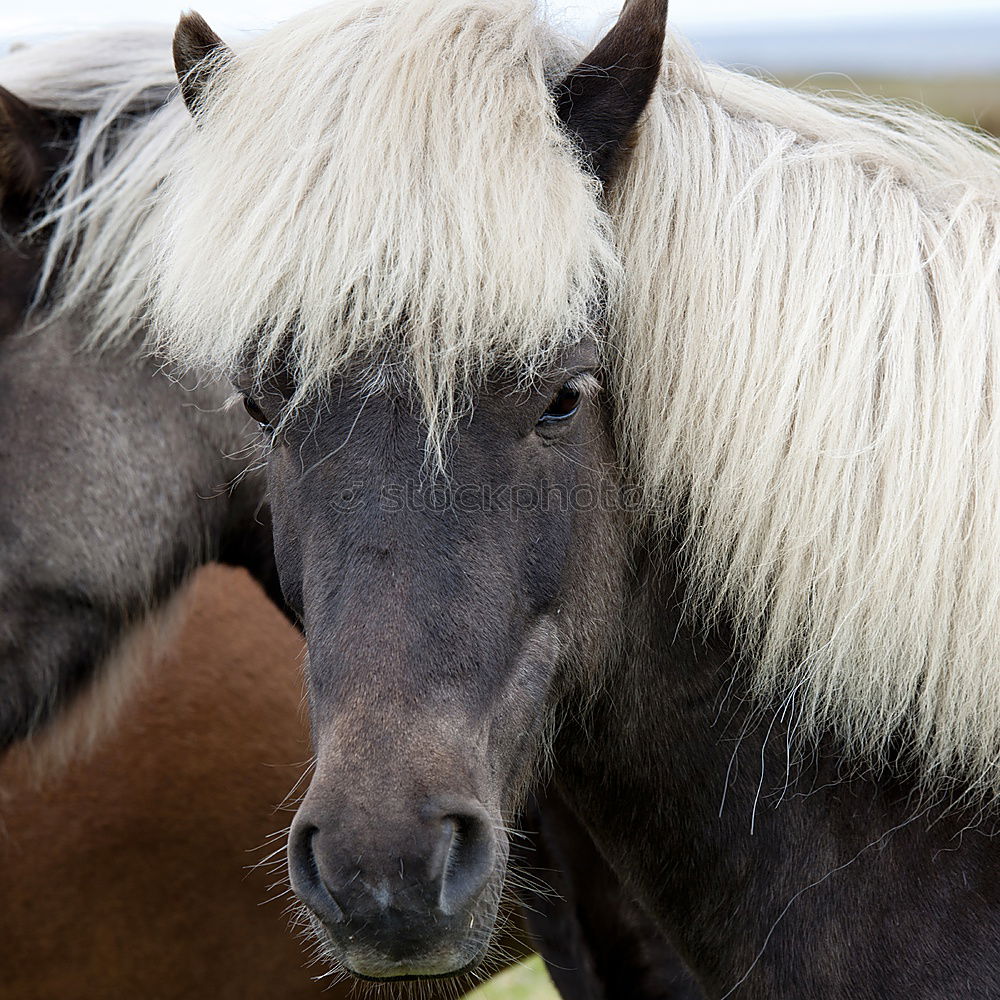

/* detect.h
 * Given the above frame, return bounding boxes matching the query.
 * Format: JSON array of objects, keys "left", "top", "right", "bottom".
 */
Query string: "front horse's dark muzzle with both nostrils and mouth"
[{"left": 289, "top": 798, "right": 502, "bottom": 980}]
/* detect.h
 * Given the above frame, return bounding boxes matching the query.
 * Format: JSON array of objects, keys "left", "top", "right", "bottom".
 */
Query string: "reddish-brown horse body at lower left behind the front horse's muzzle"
[{"left": 0, "top": 567, "right": 328, "bottom": 1000}]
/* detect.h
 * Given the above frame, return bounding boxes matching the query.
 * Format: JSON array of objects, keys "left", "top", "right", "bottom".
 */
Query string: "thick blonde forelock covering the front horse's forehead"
[{"left": 157, "top": 0, "right": 617, "bottom": 430}]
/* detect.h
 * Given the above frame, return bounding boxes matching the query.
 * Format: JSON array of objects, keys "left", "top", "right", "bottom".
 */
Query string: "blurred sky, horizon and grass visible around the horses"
[{"left": 0, "top": 0, "right": 1000, "bottom": 1000}]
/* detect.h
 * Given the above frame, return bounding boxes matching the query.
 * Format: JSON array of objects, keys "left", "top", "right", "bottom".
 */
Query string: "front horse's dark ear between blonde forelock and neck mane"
[{"left": 556, "top": 0, "right": 667, "bottom": 185}]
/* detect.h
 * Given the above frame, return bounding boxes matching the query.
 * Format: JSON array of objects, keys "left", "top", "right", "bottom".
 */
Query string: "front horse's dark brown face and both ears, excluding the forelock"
[{"left": 174, "top": 0, "right": 666, "bottom": 979}]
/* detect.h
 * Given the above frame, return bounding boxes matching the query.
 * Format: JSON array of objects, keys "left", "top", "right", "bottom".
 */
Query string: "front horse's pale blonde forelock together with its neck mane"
[{"left": 11, "top": 0, "right": 1000, "bottom": 792}]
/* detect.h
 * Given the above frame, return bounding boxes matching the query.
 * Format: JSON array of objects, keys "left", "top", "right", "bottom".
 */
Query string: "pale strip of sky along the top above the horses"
[{"left": 0, "top": 0, "right": 1000, "bottom": 37}]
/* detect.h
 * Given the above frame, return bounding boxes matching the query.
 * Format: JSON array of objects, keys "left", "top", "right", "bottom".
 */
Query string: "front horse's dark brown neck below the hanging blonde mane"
[{"left": 556, "top": 540, "right": 998, "bottom": 1000}]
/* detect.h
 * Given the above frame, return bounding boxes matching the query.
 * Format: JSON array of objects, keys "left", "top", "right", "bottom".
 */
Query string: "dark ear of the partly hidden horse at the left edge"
[{"left": 0, "top": 87, "right": 55, "bottom": 215}]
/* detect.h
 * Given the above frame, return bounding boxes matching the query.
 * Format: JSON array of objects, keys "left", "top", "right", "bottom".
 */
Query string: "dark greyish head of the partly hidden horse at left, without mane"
[{"left": 0, "top": 48, "right": 280, "bottom": 752}]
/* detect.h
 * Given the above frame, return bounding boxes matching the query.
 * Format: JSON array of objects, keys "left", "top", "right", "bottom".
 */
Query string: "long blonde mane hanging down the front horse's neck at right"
[{"left": 611, "top": 48, "right": 1000, "bottom": 790}]
